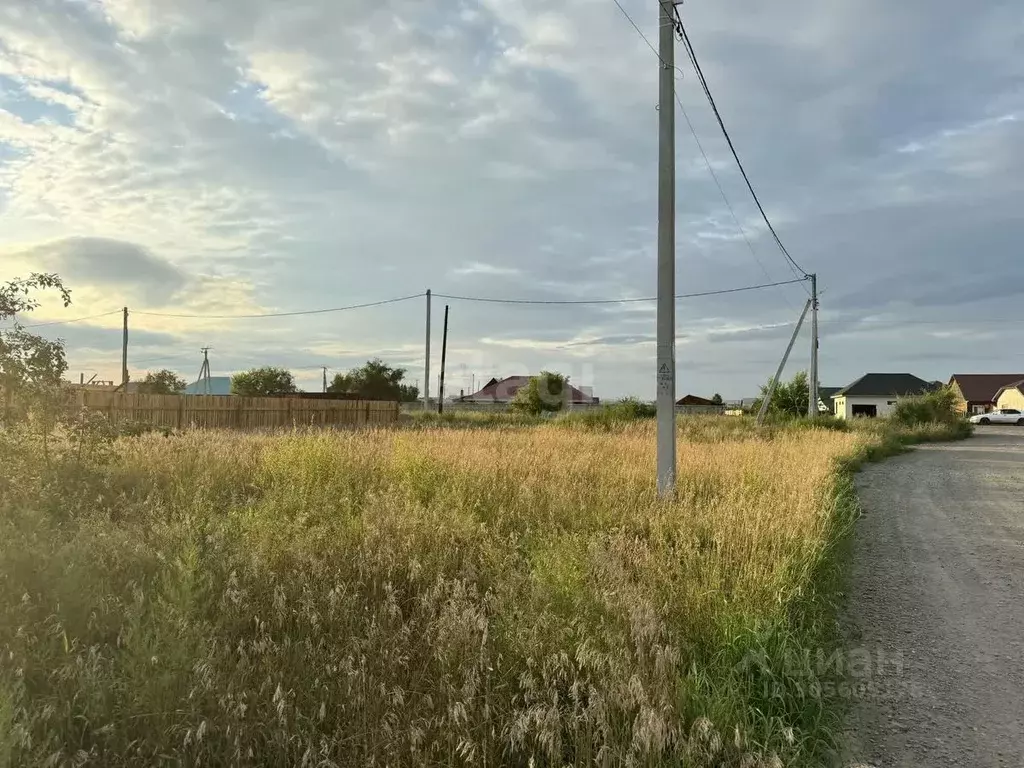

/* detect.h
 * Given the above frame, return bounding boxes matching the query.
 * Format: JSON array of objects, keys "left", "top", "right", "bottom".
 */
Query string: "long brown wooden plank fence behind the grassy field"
[{"left": 74, "top": 390, "right": 398, "bottom": 429}]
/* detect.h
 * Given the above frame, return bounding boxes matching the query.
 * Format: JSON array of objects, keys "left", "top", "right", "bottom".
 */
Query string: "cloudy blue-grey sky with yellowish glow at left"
[{"left": 0, "top": 0, "right": 1024, "bottom": 398}]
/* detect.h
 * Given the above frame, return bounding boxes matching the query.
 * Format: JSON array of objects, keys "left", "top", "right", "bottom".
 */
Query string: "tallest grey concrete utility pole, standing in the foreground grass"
[{"left": 657, "top": 0, "right": 676, "bottom": 498}]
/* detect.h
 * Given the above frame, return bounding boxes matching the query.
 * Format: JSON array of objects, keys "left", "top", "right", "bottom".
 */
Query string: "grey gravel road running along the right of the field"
[{"left": 844, "top": 427, "right": 1024, "bottom": 768}]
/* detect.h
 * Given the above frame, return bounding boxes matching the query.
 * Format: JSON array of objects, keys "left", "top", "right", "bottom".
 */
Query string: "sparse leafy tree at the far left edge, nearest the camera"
[{"left": 0, "top": 272, "right": 71, "bottom": 404}]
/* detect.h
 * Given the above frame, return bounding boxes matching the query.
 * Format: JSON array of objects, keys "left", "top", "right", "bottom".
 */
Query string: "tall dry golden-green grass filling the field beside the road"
[{"left": 0, "top": 420, "right": 866, "bottom": 767}]
